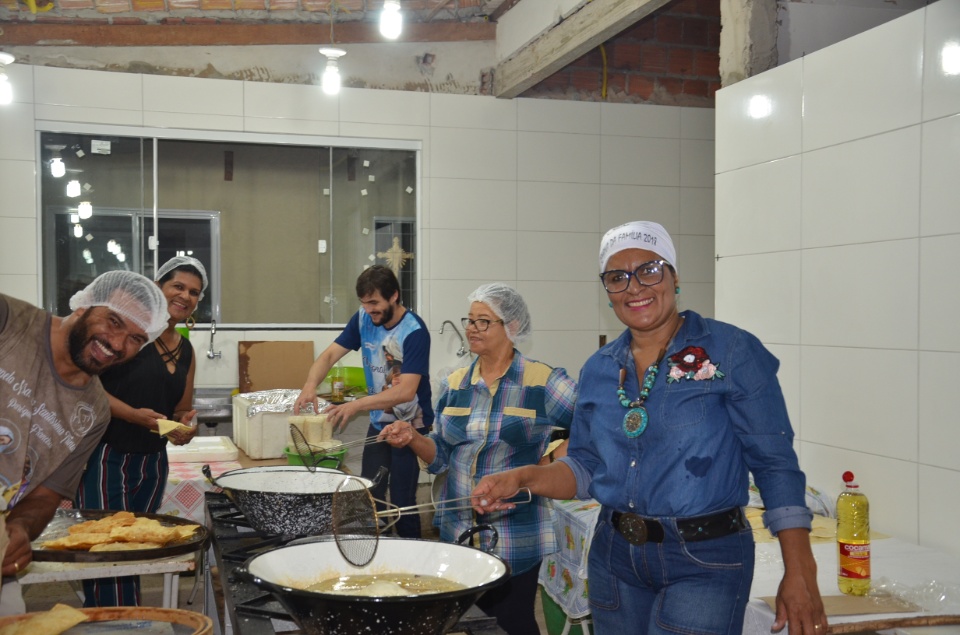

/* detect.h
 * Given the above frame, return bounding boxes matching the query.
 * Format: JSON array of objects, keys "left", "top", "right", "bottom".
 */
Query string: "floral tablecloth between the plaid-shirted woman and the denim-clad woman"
[{"left": 540, "top": 500, "right": 600, "bottom": 619}]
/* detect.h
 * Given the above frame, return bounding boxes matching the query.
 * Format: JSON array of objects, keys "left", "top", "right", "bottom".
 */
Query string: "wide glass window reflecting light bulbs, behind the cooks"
[{"left": 41, "top": 133, "right": 418, "bottom": 324}]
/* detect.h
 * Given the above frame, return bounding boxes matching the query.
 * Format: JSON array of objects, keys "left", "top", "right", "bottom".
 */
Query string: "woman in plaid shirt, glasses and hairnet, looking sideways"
[{"left": 380, "top": 283, "right": 576, "bottom": 635}]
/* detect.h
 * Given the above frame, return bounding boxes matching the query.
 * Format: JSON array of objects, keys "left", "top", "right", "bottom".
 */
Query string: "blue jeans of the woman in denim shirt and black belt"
[{"left": 588, "top": 509, "right": 754, "bottom": 635}]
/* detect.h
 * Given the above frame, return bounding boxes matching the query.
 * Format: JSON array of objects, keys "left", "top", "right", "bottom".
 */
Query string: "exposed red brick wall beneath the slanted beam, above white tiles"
[{"left": 520, "top": 0, "right": 720, "bottom": 108}]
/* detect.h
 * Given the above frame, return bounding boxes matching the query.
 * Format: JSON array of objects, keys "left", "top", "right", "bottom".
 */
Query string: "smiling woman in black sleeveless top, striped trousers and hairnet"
[{"left": 74, "top": 256, "right": 207, "bottom": 607}]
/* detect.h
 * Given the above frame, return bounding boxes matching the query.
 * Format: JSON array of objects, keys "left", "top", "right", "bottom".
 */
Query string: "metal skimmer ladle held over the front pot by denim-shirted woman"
[{"left": 333, "top": 476, "right": 533, "bottom": 567}]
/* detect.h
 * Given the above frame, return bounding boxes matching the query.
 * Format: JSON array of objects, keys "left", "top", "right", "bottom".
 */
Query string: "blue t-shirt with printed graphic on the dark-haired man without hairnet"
[{"left": 336, "top": 309, "right": 433, "bottom": 430}]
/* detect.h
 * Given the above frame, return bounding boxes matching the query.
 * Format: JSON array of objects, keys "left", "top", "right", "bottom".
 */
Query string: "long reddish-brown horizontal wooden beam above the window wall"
[{"left": 0, "top": 22, "right": 497, "bottom": 46}]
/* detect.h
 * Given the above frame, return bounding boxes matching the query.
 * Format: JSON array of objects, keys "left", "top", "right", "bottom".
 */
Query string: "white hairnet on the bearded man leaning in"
[{"left": 70, "top": 271, "right": 170, "bottom": 343}]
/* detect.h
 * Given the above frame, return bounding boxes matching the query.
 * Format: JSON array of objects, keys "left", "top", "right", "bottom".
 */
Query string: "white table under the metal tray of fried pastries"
[{"left": 18, "top": 553, "right": 206, "bottom": 609}]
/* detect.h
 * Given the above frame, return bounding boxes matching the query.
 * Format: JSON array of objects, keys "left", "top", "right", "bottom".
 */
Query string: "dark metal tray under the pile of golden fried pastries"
[{"left": 32, "top": 509, "right": 209, "bottom": 562}]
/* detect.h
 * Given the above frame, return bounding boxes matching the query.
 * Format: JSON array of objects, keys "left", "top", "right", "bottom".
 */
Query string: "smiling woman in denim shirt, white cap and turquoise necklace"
[{"left": 473, "top": 221, "right": 827, "bottom": 635}]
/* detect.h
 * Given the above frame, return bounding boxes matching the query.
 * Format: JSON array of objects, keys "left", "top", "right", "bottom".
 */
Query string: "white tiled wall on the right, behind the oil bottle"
[{"left": 716, "top": 2, "right": 960, "bottom": 555}]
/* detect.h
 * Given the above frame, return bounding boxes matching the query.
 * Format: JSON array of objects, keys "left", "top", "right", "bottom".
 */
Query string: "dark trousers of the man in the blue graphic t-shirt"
[{"left": 360, "top": 424, "right": 429, "bottom": 538}]
